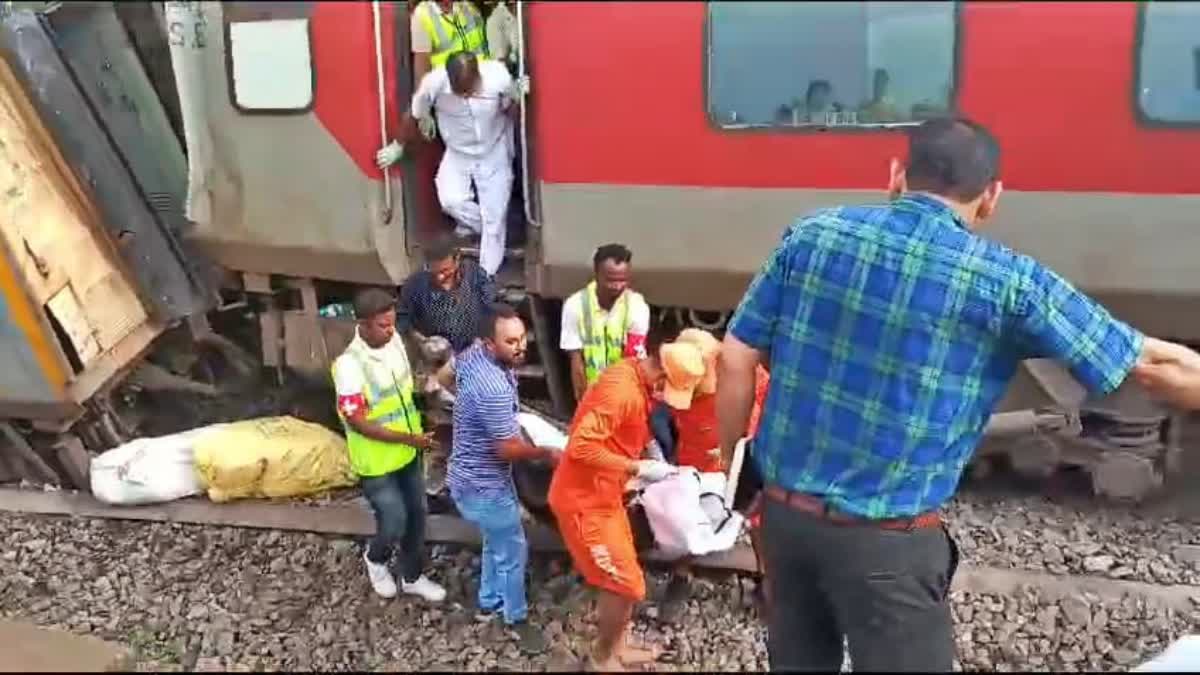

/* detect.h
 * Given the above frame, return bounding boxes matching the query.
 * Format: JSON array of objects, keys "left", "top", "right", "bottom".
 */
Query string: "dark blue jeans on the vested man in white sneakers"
[{"left": 360, "top": 455, "right": 425, "bottom": 583}]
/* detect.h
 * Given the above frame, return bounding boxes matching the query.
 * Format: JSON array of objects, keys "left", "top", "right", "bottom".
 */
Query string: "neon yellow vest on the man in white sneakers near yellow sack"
[{"left": 332, "top": 342, "right": 422, "bottom": 477}]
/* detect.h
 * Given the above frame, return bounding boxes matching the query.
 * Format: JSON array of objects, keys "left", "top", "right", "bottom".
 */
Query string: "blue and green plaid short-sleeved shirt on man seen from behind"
[{"left": 730, "top": 195, "right": 1142, "bottom": 519}]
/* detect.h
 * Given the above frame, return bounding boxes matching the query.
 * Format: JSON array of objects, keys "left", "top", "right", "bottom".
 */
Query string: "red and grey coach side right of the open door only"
[{"left": 526, "top": 2, "right": 1200, "bottom": 339}]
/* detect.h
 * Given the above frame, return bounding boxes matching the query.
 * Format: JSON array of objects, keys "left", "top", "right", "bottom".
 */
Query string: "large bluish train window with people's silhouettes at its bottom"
[{"left": 707, "top": 0, "right": 958, "bottom": 129}]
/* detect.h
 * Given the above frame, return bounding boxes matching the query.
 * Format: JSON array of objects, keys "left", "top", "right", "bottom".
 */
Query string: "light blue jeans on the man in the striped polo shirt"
[{"left": 450, "top": 482, "right": 529, "bottom": 623}]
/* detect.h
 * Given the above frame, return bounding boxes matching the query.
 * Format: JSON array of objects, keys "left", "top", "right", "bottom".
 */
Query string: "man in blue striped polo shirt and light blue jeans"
[{"left": 449, "top": 304, "right": 557, "bottom": 652}]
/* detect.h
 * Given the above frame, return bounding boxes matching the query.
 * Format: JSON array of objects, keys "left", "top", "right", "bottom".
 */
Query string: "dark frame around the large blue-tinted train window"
[{"left": 700, "top": 0, "right": 964, "bottom": 136}]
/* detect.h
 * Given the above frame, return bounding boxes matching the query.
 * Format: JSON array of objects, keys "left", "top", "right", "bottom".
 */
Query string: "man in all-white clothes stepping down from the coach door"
[{"left": 376, "top": 52, "right": 529, "bottom": 276}]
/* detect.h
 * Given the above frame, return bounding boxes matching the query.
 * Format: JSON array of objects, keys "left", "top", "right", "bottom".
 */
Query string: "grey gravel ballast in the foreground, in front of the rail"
[{"left": 0, "top": 514, "right": 1200, "bottom": 670}]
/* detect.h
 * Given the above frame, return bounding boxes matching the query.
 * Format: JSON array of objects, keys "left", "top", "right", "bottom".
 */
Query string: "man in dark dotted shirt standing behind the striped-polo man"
[{"left": 396, "top": 235, "right": 497, "bottom": 503}]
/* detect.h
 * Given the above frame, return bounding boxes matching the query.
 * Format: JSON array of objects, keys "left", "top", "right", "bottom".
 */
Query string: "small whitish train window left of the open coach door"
[{"left": 227, "top": 18, "right": 314, "bottom": 113}]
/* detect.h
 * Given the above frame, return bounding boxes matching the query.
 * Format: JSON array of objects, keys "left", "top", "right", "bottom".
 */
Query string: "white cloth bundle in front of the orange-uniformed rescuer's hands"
[{"left": 638, "top": 467, "right": 744, "bottom": 557}]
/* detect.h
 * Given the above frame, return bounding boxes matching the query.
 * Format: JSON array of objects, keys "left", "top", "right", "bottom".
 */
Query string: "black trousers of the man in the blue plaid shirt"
[{"left": 762, "top": 498, "right": 959, "bottom": 673}]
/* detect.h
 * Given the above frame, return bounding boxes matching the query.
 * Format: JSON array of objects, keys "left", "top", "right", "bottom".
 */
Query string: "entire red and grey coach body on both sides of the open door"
[{"left": 166, "top": 0, "right": 1200, "bottom": 340}]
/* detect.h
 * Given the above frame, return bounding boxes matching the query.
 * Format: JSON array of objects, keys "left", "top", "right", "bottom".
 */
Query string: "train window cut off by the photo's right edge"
[{"left": 1136, "top": 2, "right": 1200, "bottom": 125}]
